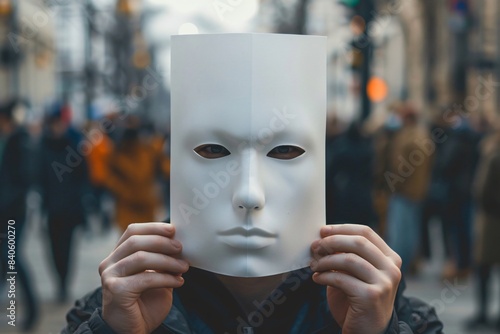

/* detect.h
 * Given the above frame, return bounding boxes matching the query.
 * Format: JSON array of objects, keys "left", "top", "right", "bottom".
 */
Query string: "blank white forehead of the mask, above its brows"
[{"left": 172, "top": 34, "right": 326, "bottom": 146}]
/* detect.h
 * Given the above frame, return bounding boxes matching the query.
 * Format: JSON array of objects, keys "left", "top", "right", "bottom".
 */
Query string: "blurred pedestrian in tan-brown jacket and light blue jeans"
[{"left": 384, "top": 103, "right": 432, "bottom": 273}]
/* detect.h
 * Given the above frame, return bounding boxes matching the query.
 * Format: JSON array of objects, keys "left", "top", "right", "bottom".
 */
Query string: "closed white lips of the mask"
[{"left": 218, "top": 226, "right": 278, "bottom": 250}]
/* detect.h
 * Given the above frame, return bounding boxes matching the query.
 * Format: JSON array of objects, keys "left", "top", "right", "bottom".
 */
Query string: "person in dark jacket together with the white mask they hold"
[{"left": 63, "top": 34, "right": 442, "bottom": 334}]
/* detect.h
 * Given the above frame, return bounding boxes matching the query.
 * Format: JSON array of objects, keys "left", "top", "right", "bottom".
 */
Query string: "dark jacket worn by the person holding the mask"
[{"left": 62, "top": 268, "right": 443, "bottom": 334}]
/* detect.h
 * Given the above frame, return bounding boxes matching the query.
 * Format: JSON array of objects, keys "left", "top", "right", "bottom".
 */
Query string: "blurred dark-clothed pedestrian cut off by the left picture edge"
[{"left": 0, "top": 99, "right": 38, "bottom": 331}]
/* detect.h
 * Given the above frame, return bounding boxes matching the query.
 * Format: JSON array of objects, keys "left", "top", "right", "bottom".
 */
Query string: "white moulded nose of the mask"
[{"left": 233, "top": 152, "right": 266, "bottom": 211}]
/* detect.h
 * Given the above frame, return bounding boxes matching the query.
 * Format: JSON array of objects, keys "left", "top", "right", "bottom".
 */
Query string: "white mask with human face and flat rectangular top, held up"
[{"left": 171, "top": 34, "right": 326, "bottom": 277}]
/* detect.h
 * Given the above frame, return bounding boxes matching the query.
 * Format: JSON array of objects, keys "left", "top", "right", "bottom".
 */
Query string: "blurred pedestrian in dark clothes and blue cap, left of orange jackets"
[{"left": 39, "top": 103, "right": 89, "bottom": 302}]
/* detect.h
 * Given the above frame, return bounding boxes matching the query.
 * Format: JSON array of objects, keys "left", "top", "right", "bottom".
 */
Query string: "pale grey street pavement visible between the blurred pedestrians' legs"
[{"left": 0, "top": 209, "right": 500, "bottom": 334}]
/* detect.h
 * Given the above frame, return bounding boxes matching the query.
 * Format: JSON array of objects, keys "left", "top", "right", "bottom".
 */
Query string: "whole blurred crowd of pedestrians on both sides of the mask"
[{"left": 0, "top": 94, "right": 500, "bottom": 329}]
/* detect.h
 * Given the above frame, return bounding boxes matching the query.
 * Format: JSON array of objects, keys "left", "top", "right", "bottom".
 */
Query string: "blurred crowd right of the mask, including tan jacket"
[{"left": 326, "top": 102, "right": 500, "bottom": 329}]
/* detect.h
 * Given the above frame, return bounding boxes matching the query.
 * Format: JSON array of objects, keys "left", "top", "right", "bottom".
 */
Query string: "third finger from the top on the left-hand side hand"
[{"left": 103, "top": 251, "right": 189, "bottom": 277}]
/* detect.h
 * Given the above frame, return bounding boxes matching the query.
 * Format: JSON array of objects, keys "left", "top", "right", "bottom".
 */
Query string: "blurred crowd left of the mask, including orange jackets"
[{"left": 0, "top": 99, "right": 170, "bottom": 330}]
